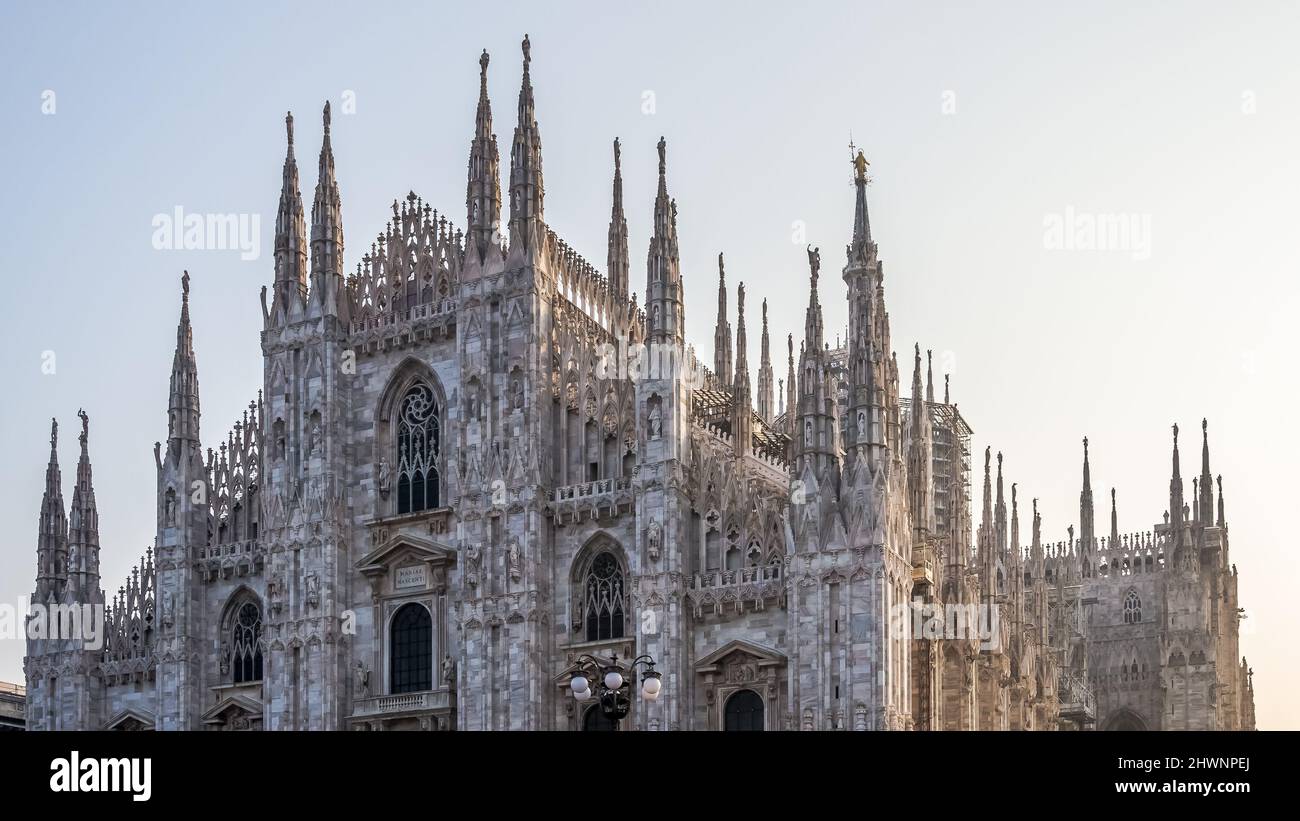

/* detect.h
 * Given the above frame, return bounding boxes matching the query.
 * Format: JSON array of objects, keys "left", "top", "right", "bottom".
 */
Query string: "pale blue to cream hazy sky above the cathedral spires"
[{"left": 0, "top": 0, "right": 1300, "bottom": 727}]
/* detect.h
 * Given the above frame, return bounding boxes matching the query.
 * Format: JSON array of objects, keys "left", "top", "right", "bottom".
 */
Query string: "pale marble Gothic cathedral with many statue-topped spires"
[{"left": 25, "top": 39, "right": 1255, "bottom": 730}]
